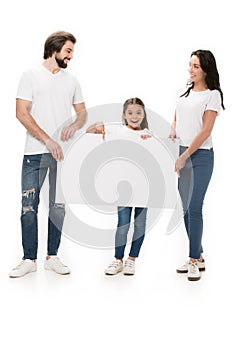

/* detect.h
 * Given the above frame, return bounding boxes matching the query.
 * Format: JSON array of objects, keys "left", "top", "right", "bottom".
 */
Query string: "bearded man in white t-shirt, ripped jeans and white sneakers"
[{"left": 9, "top": 31, "right": 87, "bottom": 277}]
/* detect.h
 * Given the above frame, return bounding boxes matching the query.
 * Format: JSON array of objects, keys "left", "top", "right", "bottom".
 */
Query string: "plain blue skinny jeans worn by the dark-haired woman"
[{"left": 178, "top": 147, "right": 214, "bottom": 259}]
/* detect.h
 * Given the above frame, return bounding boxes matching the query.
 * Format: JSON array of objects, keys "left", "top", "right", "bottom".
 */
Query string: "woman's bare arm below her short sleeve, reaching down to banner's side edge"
[{"left": 175, "top": 110, "right": 218, "bottom": 176}]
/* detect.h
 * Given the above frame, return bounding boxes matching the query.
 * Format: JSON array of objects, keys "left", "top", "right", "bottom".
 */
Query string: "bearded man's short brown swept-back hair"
[{"left": 44, "top": 31, "right": 76, "bottom": 60}]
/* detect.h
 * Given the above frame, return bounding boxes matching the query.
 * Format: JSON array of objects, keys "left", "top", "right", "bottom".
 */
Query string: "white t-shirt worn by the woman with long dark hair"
[{"left": 176, "top": 90, "right": 221, "bottom": 149}]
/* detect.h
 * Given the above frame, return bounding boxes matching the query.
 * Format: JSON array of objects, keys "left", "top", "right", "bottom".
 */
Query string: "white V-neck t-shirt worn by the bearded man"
[{"left": 16, "top": 65, "right": 83, "bottom": 154}]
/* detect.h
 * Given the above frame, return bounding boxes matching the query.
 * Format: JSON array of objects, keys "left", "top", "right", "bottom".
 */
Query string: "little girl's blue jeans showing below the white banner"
[{"left": 115, "top": 207, "right": 147, "bottom": 259}]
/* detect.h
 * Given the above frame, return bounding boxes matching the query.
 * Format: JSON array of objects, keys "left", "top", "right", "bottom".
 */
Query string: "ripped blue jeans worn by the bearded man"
[{"left": 21, "top": 153, "right": 65, "bottom": 260}]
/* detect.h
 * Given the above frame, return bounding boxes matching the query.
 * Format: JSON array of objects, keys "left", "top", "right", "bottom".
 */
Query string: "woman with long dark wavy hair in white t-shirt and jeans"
[{"left": 170, "top": 50, "right": 224, "bottom": 281}]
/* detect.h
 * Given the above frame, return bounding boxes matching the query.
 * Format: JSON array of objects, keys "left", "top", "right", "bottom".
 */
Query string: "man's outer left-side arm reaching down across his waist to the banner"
[{"left": 16, "top": 98, "right": 63, "bottom": 161}]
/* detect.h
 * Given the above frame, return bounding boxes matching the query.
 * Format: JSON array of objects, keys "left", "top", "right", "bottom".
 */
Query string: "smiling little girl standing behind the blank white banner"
[{"left": 86, "top": 98, "right": 150, "bottom": 275}]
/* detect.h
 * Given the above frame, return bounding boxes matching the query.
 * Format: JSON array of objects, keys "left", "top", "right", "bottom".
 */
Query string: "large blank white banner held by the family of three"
[{"left": 56, "top": 133, "right": 178, "bottom": 208}]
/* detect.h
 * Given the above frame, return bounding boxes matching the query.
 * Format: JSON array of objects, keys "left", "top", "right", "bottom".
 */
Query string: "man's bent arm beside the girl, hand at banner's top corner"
[{"left": 61, "top": 102, "right": 87, "bottom": 141}]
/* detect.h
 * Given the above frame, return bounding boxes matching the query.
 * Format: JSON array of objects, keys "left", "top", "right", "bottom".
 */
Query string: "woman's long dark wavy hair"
[{"left": 180, "top": 50, "right": 225, "bottom": 109}]
